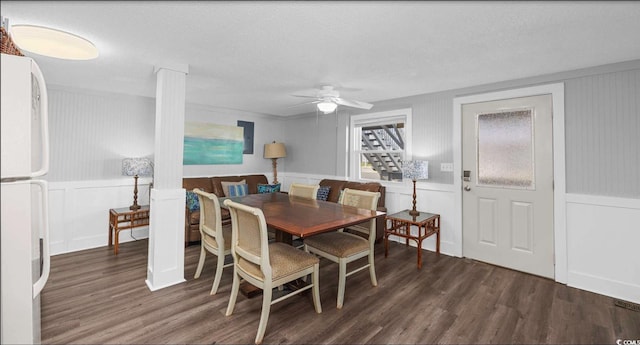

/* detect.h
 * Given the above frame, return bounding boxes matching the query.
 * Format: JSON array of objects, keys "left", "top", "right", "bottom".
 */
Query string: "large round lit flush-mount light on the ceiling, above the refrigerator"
[{"left": 11, "top": 25, "right": 98, "bottom": 60}]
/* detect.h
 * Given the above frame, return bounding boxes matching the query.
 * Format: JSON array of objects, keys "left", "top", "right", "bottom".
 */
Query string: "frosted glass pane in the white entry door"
[{"left": 476, "top": 109, "right": 535, "bottom": 190}]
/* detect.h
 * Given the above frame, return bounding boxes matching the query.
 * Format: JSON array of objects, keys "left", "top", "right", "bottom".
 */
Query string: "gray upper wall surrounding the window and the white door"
[{"left": 285, "top": 60, "right": 640, "bottom": 198}]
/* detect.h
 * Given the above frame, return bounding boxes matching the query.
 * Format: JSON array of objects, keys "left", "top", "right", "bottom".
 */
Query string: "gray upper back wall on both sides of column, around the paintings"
[{"left": 46, "top": 85, "right": 284, "bottom": 182}]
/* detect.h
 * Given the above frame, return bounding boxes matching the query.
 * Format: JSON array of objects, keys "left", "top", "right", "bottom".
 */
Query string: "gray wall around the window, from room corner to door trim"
[{"left": 285, "top": 92, "right": 460, "bottom": 184}]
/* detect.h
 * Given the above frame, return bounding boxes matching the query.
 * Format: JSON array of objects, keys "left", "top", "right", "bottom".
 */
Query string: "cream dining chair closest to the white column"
[{"left": 193, "top": 188, "right": 233, "bottom": 295}]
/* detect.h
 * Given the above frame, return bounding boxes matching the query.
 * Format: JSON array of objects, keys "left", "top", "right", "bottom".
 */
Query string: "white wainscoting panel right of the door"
[{"left": 567, "top": 194, "right": 640, "bottom": 303}]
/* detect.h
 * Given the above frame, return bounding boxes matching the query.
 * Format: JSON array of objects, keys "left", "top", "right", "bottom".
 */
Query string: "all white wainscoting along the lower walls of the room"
[{"left": 49, "top": 173, "right": 640, "bottom": 303}]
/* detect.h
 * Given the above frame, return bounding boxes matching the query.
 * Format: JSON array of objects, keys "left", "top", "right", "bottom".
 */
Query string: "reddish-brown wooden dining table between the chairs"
[{"left": 220, "top": 193, "right": 386, "bottom": 243}]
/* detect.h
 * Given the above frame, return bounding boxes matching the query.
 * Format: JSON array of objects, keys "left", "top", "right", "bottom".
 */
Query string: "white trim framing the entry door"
[{"left": 453, "top": 83, "right": 568, "bottom": 284}]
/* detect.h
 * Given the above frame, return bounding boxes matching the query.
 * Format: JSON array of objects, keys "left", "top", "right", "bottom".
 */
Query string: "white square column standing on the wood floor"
[{"left": 146, "top": 65, "right": 189, "bottom": 291}]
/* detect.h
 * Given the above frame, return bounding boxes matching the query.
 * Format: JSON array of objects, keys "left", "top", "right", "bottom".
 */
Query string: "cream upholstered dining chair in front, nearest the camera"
[{"left": 224, "top": 200, "right": 322, "bottom": 344}]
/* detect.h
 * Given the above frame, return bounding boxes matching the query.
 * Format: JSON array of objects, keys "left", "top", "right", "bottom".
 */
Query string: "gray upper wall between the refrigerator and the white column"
[{"left": 46, "top": 85, "right": 155, "bottom": 181}]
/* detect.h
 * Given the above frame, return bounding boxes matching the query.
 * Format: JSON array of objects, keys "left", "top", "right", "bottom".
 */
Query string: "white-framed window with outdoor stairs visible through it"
[{"left": 349, "top": 109, "right": 411, "bottom": 181}]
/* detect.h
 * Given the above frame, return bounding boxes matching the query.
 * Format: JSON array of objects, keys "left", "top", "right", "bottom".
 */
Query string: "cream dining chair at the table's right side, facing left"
[{"left": 304, "top": 188, "right": 380, "bottom": 309}]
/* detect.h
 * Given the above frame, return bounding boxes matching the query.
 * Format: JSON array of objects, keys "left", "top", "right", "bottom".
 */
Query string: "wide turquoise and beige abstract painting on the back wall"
[{"left": 182, "top": 122, "right": 244, "bottom": 165}]
